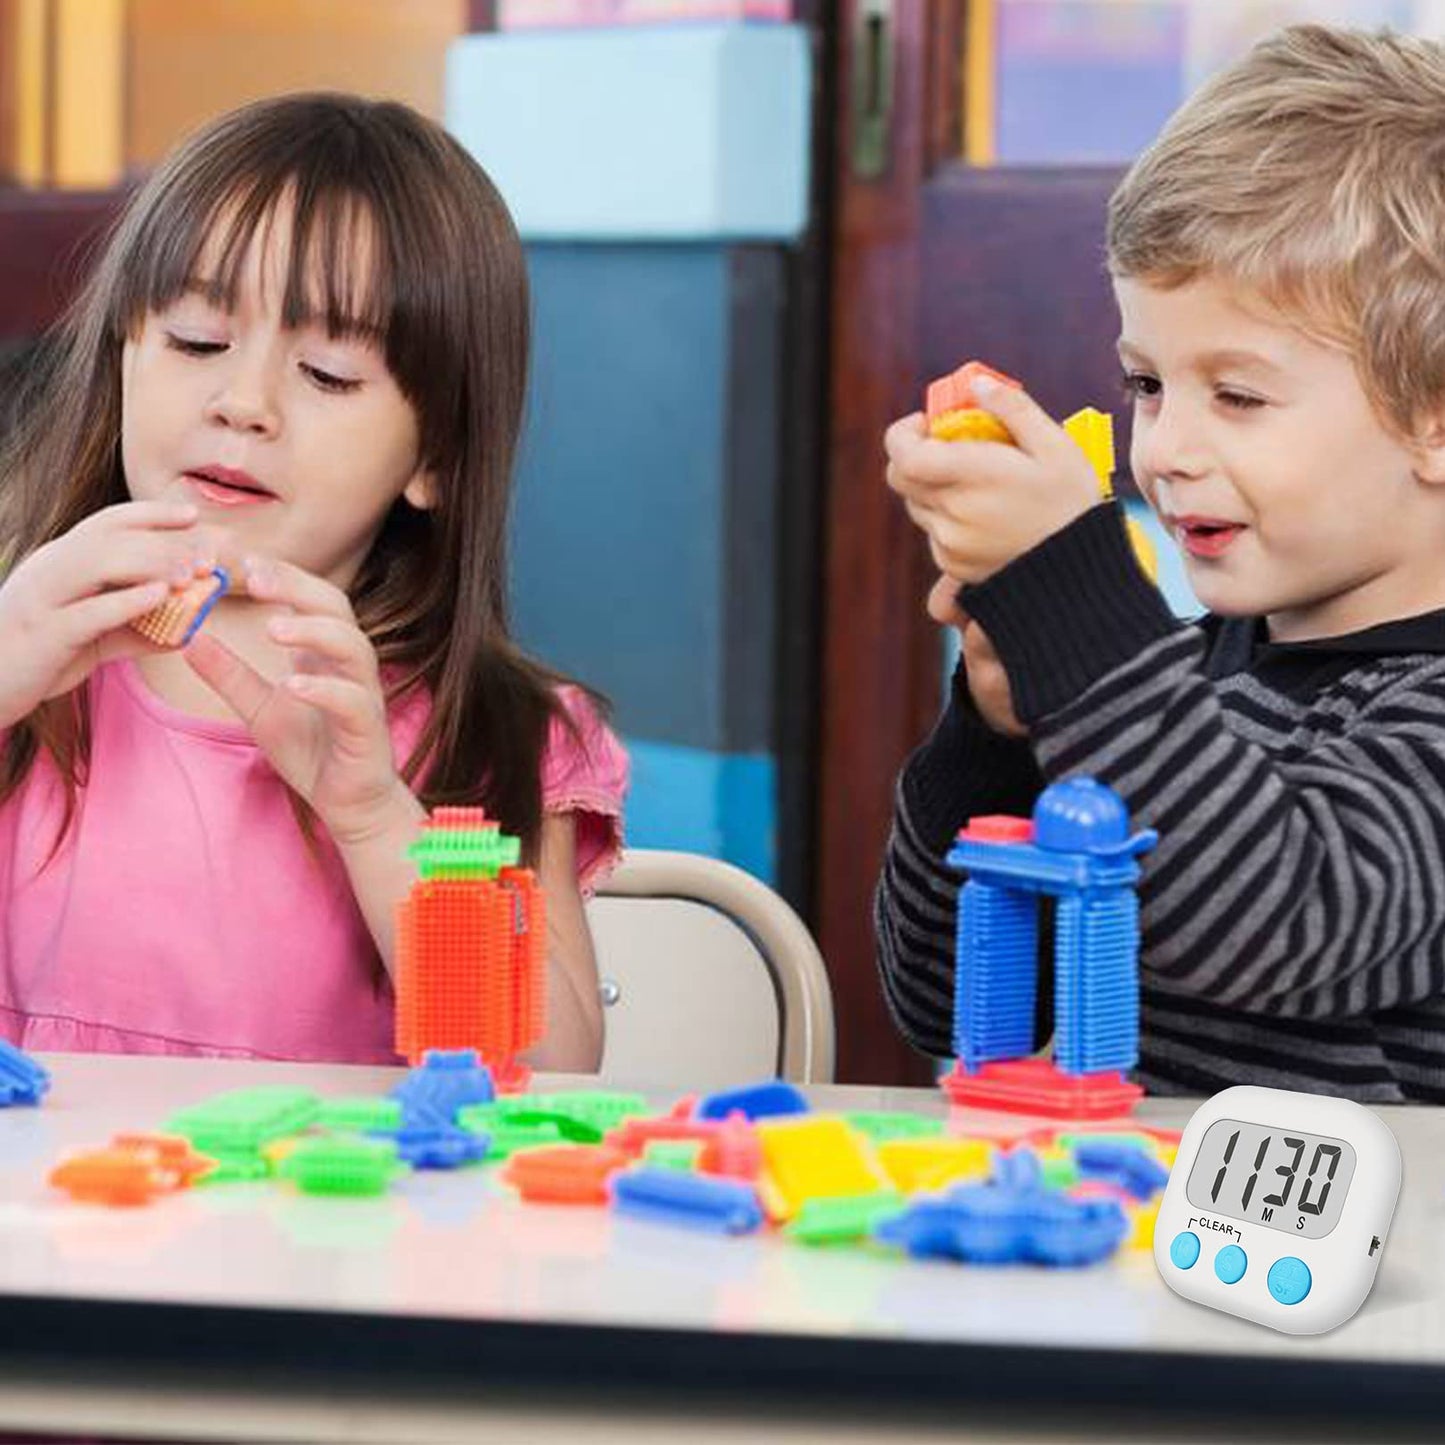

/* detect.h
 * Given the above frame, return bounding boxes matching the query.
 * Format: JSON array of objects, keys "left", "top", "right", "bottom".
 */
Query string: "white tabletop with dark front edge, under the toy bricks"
[{"left": 0, "top": 1055, "right": 1445, "bottom": 1445}]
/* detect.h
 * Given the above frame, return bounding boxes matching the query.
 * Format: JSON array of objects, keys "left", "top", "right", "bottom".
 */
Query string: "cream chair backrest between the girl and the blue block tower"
[{"left": 587, "top": 848, "right": 834, "bottom": 1088}]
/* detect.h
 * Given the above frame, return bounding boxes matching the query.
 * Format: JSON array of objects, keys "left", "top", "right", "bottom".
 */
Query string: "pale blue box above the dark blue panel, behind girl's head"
[{"left": 445, "top": 25, "right": 812, "bottom": 241}]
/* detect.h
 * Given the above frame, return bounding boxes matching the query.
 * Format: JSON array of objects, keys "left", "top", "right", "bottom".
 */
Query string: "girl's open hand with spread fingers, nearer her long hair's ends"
[{"left": 185, "top": 559, "right": 415, "bottom": 847}]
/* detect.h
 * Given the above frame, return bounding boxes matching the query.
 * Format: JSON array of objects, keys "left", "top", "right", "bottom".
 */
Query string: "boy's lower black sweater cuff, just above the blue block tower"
[{"left": 899, "top": 662, "right": 1043, "bottom": 855}]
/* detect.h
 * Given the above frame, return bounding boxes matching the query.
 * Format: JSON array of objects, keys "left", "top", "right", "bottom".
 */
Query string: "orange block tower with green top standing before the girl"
[{"left": 396, "top": 808, "right": 546, "bottom": 1091}]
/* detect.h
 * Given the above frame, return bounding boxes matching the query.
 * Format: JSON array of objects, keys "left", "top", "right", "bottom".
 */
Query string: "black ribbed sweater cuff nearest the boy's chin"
[{"left": 958, "top": 501, "right": 1183, "bottom": 725}]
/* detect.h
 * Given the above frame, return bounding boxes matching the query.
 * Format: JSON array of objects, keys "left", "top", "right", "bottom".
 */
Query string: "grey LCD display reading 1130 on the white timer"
[{"left": 1185, "top": 1118, "right": 1355, "bottom": 1240}]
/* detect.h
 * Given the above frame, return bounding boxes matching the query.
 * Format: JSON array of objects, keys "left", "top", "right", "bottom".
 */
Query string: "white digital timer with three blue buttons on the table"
[{"left": 1155, "top": 1087, "right": 1400, "bottom": 1335}]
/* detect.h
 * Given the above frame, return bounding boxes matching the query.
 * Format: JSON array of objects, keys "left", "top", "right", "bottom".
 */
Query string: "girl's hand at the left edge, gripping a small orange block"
[{"left": 0, "top": 501, "right": 215, "bottom": 727}]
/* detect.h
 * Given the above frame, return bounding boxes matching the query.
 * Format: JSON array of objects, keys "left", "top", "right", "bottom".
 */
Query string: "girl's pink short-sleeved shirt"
[{"left": 0, "top": 662, "right": 627, "bottom": 1064}]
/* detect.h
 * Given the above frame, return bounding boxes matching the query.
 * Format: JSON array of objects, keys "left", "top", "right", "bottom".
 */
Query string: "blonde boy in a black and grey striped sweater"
[{"left": 877, "top": 26, "right": 1445, "bottom": 1103}]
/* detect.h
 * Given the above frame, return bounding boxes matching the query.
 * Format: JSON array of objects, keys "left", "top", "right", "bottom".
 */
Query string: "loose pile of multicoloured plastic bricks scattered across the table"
[{"left": 36, "top": 1051, "right": 1179, "bottom": 1266}]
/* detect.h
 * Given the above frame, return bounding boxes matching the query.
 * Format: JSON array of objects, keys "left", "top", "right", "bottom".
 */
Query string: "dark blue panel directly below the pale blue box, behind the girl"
[{"left": 512, "top": 246, "right": 782, "bottom": 753}]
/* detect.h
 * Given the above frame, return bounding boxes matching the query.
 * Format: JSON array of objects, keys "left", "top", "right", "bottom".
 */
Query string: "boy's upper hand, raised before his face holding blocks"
[{"left": 883, "top": 383, "right": 1100, "bottom": 582}]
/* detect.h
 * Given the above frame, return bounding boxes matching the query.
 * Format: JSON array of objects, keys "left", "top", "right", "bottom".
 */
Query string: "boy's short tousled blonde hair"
[{"left": 1108, "top": 25, "right": 1445, "bottom": 436}]
